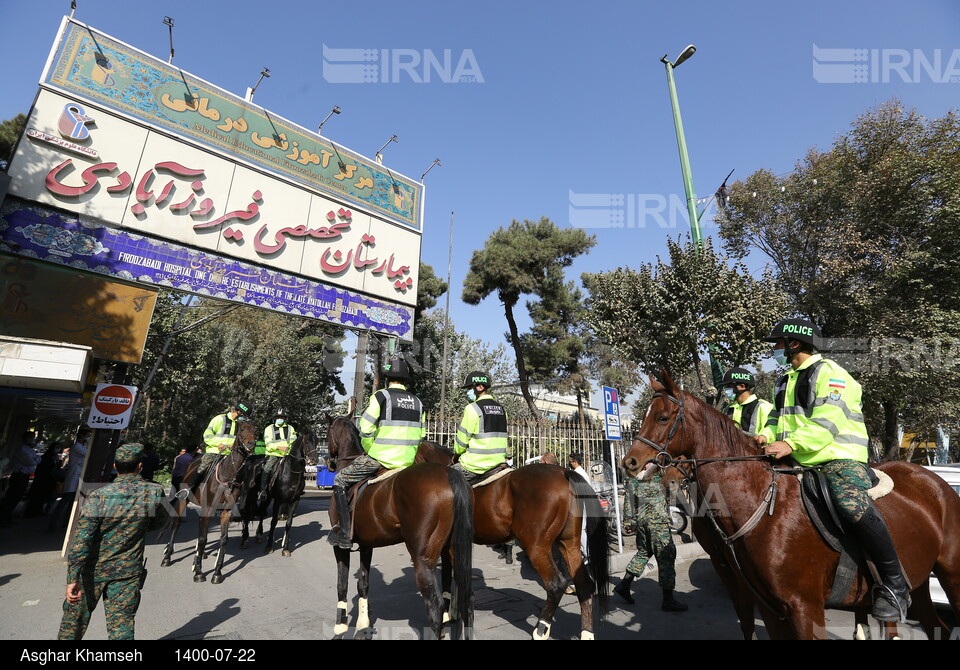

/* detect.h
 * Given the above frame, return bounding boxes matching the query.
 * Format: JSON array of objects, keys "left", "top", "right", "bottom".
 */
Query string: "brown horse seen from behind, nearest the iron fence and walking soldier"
[{"left": 417, "top": 442, "right": 609, "bottom": 640}]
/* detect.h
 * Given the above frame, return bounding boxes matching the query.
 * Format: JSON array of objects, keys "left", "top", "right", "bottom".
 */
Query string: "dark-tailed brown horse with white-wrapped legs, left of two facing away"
[{"left": 327, "top": 417, "right": 473, "bottom": 639}]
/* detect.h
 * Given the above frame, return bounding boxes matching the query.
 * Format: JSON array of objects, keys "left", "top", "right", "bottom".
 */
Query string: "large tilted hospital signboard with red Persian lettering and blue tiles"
[{"left": 0, "top": 19, "right": 423, "bottom": 338}]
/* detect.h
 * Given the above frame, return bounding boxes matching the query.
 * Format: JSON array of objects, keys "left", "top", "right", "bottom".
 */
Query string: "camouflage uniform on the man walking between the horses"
[{"left": 623, "top": 475, "right": 677, "bottom": 590}]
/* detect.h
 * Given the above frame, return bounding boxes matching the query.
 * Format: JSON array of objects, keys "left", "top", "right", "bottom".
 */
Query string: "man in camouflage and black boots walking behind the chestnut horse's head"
[{"left": 613, "top": 463, "right": 687, "bottom": 612}]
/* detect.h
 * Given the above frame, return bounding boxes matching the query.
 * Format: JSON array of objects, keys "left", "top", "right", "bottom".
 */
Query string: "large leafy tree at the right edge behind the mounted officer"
[{"left": 718, "top": 100, "right": 960, "bottom": 458}]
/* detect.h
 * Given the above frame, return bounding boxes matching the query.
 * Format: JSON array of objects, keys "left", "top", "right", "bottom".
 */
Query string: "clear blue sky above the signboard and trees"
[{"left": 0, "top": 0, "right": 960, "bottom": 400}]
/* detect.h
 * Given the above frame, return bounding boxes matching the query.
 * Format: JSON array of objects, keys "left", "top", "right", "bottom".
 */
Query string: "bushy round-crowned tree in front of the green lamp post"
[{"left": 582, "top": 238, "right": 786, "bottom": 398}]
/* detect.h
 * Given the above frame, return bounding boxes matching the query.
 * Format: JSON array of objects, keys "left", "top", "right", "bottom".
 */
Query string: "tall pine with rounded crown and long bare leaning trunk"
[{"left": 463, "top": 217, "right": 596, "bottom": 416}]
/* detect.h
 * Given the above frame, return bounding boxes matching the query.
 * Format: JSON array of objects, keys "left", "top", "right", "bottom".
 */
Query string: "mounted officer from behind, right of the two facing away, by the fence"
[{"left": 453, "top": 372, "right": 507, "bottom": 483}]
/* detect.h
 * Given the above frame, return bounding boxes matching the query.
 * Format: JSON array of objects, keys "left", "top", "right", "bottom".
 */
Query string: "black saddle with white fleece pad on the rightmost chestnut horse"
[{"left": 798, "top": 467, "right": 893, "bottom": 608}]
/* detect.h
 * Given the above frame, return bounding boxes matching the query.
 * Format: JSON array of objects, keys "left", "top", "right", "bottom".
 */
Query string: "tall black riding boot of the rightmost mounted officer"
[{"left": 853, "top": 506, "right": 910, "bottom": 623}]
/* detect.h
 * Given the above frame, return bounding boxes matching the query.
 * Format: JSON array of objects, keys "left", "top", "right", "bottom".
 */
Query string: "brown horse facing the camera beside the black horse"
[{"left": 160, "top": 421, "right": 257, "bottom": 584}]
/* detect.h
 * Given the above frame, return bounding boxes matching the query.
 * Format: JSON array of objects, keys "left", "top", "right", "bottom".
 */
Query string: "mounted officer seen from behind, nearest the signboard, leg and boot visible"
[{"left": 327, "top": 358, "right": 425, "bottom": 549}]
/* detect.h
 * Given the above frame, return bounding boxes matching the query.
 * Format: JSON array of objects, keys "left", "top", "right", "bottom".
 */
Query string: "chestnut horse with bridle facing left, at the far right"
[{"left": 623, "top": 375, "right": 960, "bottom": 639}]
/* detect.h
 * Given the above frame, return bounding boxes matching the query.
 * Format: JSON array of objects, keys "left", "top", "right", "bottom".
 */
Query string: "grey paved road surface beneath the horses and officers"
[{"left": 0, "top": 492, "right": 940, "bottom": 641}]
